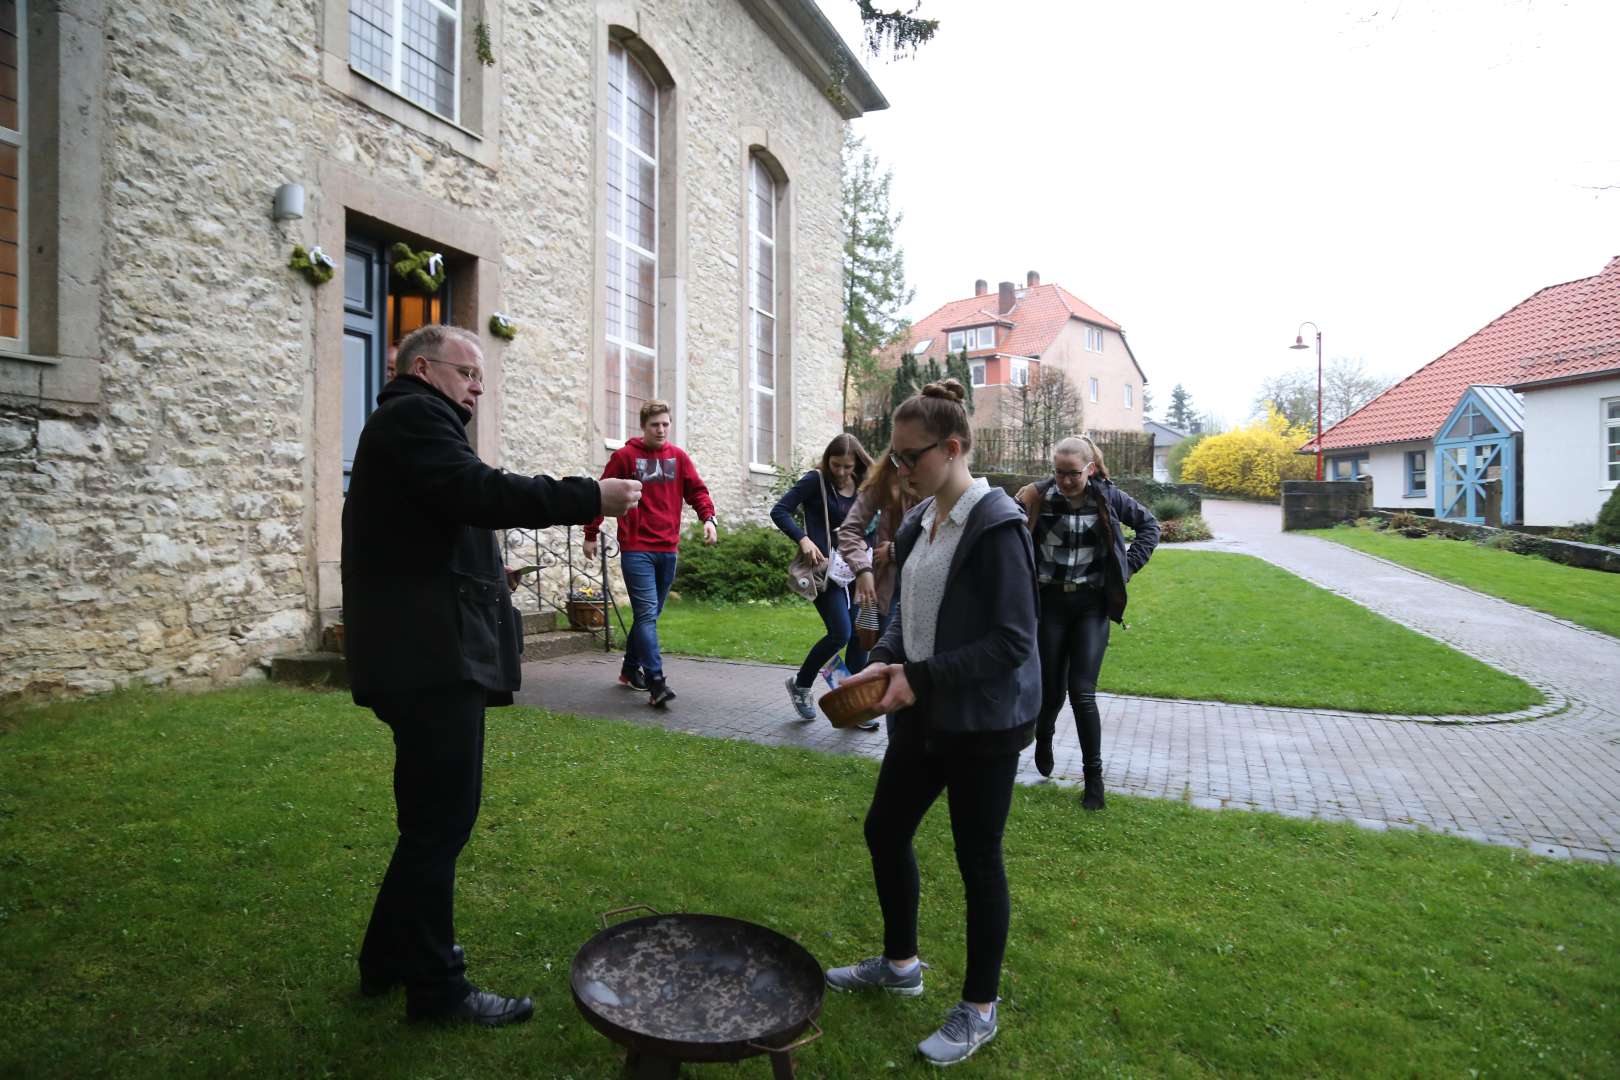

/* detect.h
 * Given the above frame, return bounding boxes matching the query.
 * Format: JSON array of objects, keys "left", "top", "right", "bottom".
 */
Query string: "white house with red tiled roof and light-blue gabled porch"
[{"left": 1301, "top": 257, "right": 1620, "bottom": 525}]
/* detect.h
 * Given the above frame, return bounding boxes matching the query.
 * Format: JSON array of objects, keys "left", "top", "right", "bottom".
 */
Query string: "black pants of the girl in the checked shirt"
[{"left": 1035, "top": 586, "right": 1108, "bottom": 769}]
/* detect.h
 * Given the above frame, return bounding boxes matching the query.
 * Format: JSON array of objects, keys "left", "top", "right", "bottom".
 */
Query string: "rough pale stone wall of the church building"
[{"left": 0, "top": 0, "right": 842, "bottom": 698}]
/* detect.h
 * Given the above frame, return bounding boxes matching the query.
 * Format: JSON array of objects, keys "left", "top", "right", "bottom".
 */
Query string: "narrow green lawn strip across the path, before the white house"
[{"left": 1307, "top": 526, "right": 1620, "bottom": 636}]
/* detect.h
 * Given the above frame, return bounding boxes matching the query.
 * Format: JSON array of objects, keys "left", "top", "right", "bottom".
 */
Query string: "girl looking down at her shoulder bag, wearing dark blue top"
[{"left": 771, "top": 434, "right": 876, "bottom": 727}]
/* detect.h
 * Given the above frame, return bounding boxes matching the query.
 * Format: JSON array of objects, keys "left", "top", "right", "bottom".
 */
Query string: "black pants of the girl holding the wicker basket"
[{"left": 867, "top": 742, "right": 1019, "bottom": 1002}]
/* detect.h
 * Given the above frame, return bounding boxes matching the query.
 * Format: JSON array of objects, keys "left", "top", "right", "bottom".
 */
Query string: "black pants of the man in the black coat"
[{"left": 360, "top": 683, "right": 486, "bottom": 1015}]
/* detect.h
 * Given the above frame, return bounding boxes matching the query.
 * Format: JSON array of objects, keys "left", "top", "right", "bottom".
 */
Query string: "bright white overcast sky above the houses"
[{"left": 820, "top": 0, "right": 1620, "bottom": 424}]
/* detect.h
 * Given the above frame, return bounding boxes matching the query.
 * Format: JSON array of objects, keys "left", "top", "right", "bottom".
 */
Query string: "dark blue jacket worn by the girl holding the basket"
[{"left": 872, "top": 489, "right": 1040, "bottom": 753}]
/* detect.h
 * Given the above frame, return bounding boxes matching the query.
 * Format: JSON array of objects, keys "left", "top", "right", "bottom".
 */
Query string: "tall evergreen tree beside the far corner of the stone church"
[{"left": 844, "top": 128, "right": 914, "bottom": 416}]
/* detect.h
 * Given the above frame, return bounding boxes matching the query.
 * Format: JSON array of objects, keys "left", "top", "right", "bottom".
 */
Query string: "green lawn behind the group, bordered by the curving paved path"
[{"left": 638, "top": 549, "right": 1542, "bottom": 716}]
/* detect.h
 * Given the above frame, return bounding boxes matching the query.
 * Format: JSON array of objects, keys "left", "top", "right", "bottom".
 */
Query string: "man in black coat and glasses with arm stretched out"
[{"left": 343, "top": 325, "right": 642, "bottom": 1027}]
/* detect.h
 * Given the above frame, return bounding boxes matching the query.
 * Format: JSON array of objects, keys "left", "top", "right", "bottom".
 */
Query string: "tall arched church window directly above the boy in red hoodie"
[{"left": 603, "top": 40, "right": 658, "bottom": 440}]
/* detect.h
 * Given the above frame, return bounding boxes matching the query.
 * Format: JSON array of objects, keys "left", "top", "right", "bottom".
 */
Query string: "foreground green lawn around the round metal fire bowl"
[{"left": 0, "top": 689, "right": 1620, "bottom": 1080}]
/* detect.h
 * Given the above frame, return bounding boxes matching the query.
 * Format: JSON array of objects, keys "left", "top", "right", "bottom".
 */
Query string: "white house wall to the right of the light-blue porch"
[{"left": 1524, "top": 379, "right": 1620, "bottom": 525}]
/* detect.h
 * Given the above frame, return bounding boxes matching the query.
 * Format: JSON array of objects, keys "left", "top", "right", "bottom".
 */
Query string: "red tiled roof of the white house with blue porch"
[{"left": 1301, "top": 259, "right": 1620, "bottom": 453}]
